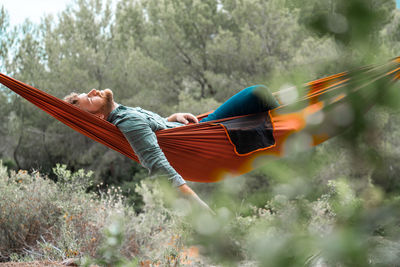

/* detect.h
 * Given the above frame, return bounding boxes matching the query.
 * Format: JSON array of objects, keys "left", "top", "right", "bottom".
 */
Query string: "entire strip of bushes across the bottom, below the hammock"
[{"left": 0, "top": 156, "right": 400, "bottom": 266}]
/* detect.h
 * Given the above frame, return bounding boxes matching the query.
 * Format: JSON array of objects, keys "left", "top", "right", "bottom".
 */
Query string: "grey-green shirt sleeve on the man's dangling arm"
[{"left": 117, "top": 116, "right": 186, "bottom": 187}]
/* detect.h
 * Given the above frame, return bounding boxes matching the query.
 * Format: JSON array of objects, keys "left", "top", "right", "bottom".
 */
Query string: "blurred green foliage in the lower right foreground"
[{"left": 183, "top": 159, "right": 399, "bottom": 266}]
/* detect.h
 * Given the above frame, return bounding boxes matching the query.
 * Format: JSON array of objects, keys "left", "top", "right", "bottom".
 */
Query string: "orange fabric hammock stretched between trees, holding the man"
[{"left": 0, "top": 58, "right": 400, "bottom": 182}]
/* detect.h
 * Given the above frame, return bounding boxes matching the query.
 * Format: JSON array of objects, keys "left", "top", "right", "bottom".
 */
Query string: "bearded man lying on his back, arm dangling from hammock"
[{"left": 64, "top": 85, "right": 279, "bottom": 214}]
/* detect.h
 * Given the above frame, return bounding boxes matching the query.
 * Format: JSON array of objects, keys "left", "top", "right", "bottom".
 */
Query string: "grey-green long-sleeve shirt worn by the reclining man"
[{"left": 107, "top": 105, "right": 185, "bottom": 186}]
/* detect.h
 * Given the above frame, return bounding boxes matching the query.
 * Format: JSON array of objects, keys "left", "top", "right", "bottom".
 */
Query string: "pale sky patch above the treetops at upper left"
[{"left": 0, "top": 0, "right": 400, "bottom": 26}]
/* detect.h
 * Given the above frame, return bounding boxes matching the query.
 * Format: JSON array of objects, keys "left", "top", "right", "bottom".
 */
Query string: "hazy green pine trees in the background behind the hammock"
[{"left": 0, "top": 0, "right": 398, "bottom": 185}]
